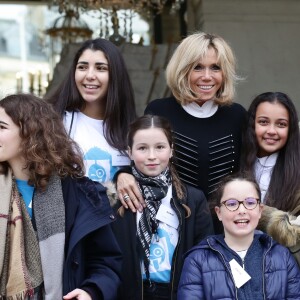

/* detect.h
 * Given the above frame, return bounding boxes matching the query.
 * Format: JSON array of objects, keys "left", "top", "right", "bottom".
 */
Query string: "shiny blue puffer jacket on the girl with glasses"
[{"left": 178, "top": 234, "right": 300, "bottom": 300}]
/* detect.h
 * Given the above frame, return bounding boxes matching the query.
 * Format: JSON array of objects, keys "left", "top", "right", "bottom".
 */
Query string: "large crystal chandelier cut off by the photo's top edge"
[{"left": 50, "top": 0, "right": 184, "bottom": 45}]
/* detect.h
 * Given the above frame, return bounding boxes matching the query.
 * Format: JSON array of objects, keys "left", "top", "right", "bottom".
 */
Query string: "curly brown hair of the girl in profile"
[{"left": 0, "top": 94, "right": 84, "bottom": 190}]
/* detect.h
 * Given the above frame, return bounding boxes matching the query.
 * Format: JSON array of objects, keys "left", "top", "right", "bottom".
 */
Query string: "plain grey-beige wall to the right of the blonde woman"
[{"left": 188, "top": 0, "right": 300, "bottom": 113}]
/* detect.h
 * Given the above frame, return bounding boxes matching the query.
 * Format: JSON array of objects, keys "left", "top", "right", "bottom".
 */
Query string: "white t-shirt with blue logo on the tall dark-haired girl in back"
[{"left": 64, "top": 112, "right": 130, "bottom": 183}]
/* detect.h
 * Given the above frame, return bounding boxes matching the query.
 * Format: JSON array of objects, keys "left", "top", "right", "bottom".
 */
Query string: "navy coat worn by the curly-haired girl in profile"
[{"left": 62, "top": 178, "right": 122, "bottom": 300}]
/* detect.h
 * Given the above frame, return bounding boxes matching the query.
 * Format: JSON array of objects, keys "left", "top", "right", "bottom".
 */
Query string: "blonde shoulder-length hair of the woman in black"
[{"left": 166, "top": 32, "right": 239, "bottom": 105}]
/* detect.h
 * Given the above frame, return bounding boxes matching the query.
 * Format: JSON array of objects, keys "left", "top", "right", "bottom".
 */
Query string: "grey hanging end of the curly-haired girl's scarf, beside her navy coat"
[{"left": 33, "top": 176, "right": 65, "bottom": 300}]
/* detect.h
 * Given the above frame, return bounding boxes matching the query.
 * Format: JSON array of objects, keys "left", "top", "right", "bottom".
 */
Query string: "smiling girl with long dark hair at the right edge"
[{"left": 241, "top": 92, "right": 300, "bottom": 211}]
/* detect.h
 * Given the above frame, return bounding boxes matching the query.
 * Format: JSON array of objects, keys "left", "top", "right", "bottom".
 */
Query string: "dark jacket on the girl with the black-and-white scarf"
[{"left": 112, "top": 186, "right": 213, "bottom": 300}]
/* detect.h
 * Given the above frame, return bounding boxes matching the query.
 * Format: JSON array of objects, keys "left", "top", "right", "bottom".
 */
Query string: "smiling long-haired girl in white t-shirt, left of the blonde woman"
[{"left": 49, "top": 38, "right": 136, "bottom": 183}]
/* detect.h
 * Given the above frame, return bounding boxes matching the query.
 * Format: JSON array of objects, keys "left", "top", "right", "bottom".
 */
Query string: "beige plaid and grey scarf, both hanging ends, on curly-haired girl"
[{"left": 0, "top": 171, "right": 65, "bottom": 300}]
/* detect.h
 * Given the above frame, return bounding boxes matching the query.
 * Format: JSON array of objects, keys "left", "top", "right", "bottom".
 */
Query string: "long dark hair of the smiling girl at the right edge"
[{"left": 241, "top": 92, "right": 300, "bottom": 211}]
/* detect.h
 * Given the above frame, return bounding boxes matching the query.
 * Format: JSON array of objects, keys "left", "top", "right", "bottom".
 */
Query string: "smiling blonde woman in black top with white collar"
[{"left": 117, "top": 32, "right": 246, "bottom": 225}]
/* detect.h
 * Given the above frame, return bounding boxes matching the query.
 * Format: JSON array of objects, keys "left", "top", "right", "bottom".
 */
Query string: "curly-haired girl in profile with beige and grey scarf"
[{"left": 0, "top": 94, "right": 121, "bottom": 300}]
